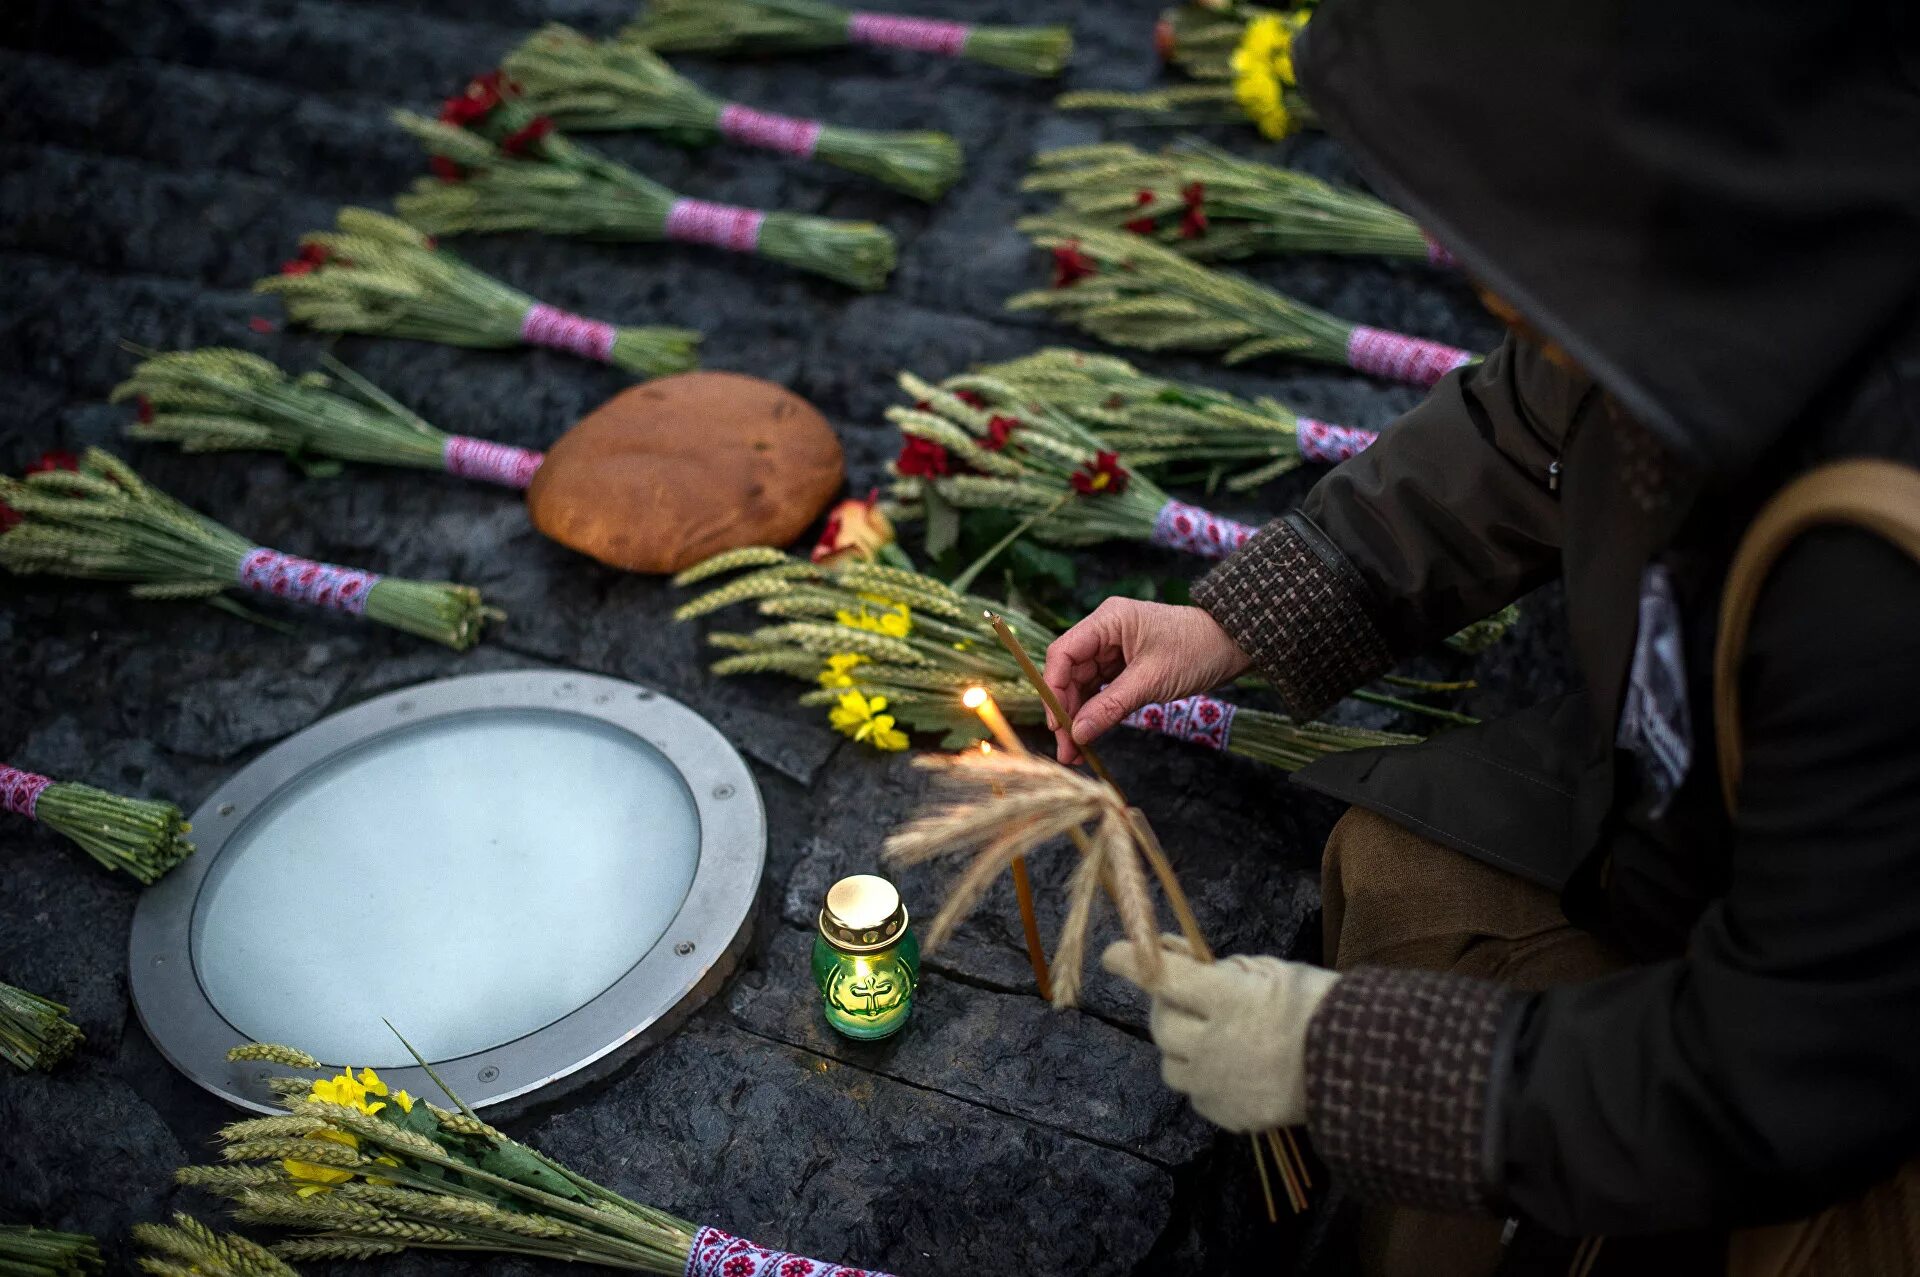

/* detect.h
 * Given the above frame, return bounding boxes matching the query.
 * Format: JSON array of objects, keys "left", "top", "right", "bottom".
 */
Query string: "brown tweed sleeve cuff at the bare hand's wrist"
[{"left": 1192, "top": 515, "right": 1394, "bottom": 718}]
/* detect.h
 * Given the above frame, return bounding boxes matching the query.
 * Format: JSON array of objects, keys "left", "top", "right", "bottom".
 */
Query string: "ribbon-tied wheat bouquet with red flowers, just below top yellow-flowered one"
[{"left": 1021, "top": 140, "right": 1453, "bottom": 265}]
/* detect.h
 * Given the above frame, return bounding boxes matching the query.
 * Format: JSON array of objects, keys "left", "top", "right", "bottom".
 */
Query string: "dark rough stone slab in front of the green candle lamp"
[{"left": 528, "top": 1016, "right": 1173, "bottom": 1275}]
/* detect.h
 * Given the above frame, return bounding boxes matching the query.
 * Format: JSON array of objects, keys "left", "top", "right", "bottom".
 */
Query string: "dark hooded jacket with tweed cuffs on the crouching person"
[{"left": 1194, "top": 0, "right": 1920, "bottom": 1235}]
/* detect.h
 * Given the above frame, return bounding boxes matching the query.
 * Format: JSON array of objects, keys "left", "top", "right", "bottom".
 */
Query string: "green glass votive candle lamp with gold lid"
[{"left": 814, "top": 874, "right": 920, "bottom": 1041}]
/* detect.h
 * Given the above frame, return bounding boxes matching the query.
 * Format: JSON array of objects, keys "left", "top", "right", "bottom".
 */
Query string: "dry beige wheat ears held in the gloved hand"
[{"left": 885, "top": 751, "right": 1160, "bottom": 1006}]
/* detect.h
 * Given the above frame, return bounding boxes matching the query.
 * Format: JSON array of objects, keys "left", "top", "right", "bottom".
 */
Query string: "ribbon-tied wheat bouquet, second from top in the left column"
[{"left": 501, "top": 25, "right": 962, "bottom": 200}]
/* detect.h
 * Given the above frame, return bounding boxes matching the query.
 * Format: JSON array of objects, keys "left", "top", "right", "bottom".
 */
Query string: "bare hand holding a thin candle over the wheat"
[{"left": 1046, "top": 599, "right": 1252, "bottom": 762}]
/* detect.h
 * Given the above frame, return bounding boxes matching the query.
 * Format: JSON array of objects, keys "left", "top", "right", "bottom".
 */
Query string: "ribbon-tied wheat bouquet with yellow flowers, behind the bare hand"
[{"left": 674, "top": 549, "right": 1419, "bottom": 770}]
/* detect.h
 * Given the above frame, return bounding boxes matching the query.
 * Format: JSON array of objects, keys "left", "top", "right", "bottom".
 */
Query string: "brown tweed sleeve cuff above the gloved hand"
[{"left": 1308, "top": 968, "right": 1524, "bottom": 1212}]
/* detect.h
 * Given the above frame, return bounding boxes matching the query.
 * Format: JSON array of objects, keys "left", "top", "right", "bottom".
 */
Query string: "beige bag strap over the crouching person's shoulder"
[{"left": 1713, "top": 461, "right": 1920, "bottom": 814}]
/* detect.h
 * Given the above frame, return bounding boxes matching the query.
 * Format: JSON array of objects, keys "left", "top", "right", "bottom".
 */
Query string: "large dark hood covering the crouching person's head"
[{"left": 1296, "top": 0, "right": 1920, "bottom": 474}]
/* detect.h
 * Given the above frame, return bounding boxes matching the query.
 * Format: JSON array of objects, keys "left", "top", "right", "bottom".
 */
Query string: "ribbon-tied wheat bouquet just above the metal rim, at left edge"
[{"left": 0, "top": 445, "right": 501, "bottom": 649}]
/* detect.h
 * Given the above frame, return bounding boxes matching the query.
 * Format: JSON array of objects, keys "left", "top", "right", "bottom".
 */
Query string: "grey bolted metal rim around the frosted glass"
[{"left": 129, "top": 670, "right": 766, "bottom": 1114}]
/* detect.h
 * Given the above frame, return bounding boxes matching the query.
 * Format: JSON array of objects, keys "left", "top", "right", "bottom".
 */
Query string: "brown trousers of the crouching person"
[{"left": 1321, "top": 807, "right": 1920, "bottom": 1277}]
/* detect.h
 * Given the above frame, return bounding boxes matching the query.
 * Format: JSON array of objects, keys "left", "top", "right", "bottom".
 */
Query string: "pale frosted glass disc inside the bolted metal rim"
[{"left": 194, "top": 711, "right": 701, "bottom": 1068}]
